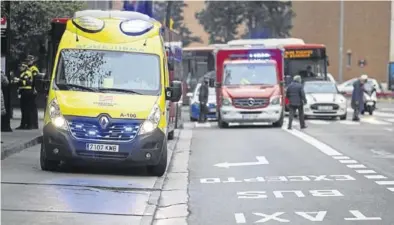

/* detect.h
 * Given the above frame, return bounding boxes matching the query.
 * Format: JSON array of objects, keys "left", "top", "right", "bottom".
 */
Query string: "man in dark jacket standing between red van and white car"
[{"left": 286, "top": 75, "right": 306, "bottom": 130}]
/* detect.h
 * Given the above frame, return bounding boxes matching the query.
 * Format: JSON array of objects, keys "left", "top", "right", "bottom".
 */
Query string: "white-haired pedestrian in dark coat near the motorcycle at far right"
[{"left": 351, "top": 74, "right": 368, "bottom": 121}]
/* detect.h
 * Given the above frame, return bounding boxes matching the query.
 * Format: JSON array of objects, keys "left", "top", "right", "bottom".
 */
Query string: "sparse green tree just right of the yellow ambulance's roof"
[{"left": 154, "top": 1, "right": 202, "bottom": 46}]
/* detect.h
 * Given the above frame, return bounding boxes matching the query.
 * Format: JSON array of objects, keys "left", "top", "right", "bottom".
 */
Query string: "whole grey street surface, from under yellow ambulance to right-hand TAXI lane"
[{"left": 1, "top": 103, "right": 394, "bottom": 225}]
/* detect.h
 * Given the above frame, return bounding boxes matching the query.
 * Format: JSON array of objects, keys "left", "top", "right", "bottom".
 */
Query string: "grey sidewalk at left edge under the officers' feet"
[{"left": 1, "top": 108, "right": 44, "bottom": 160}]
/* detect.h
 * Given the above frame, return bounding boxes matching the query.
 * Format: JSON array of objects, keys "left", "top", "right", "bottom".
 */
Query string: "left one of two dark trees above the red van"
[{"left": 195, "top": 1, "right": 244, "bottom": 43}]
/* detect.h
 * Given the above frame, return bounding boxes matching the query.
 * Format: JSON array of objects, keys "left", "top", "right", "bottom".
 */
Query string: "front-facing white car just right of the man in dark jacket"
[{"left": 304, "top": 81, "right": 347, "bottom": 120}]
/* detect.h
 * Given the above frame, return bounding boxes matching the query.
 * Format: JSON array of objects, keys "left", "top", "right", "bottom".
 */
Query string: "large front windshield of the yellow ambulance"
[{"left": 55, "top": 49, "right": 161, "bottom": 95}]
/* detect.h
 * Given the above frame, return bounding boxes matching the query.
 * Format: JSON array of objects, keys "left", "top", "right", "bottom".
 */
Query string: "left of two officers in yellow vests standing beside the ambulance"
[{"left": 15, "top": 62, "right": 34, "bottom": 130}]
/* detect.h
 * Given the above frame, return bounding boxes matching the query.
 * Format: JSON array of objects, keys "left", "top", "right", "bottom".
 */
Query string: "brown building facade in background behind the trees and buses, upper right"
[{"left": 184, "top": 1, "right": 394, "bottom": 82}]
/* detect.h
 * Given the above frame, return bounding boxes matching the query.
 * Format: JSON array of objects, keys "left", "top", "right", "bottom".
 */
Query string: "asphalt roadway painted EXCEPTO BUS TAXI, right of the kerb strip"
[{"left": 185, "top": 104, "right": 394, "bottom": 225}]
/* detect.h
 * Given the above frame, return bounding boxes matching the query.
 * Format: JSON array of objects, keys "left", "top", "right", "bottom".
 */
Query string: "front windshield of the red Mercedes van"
[{"left": 224, "top": 63, "right": 277, "bottom": 85}]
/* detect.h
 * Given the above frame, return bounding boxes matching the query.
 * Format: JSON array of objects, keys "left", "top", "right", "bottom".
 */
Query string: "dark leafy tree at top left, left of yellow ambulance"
[{"left": 1, "top": 1, "right": 86, "bottom": 69}]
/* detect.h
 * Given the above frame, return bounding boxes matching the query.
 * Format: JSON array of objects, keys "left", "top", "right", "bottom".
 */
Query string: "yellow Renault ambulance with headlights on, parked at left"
[{"left": 40, "top": 10, "right": 181, "bottom": 176}]
